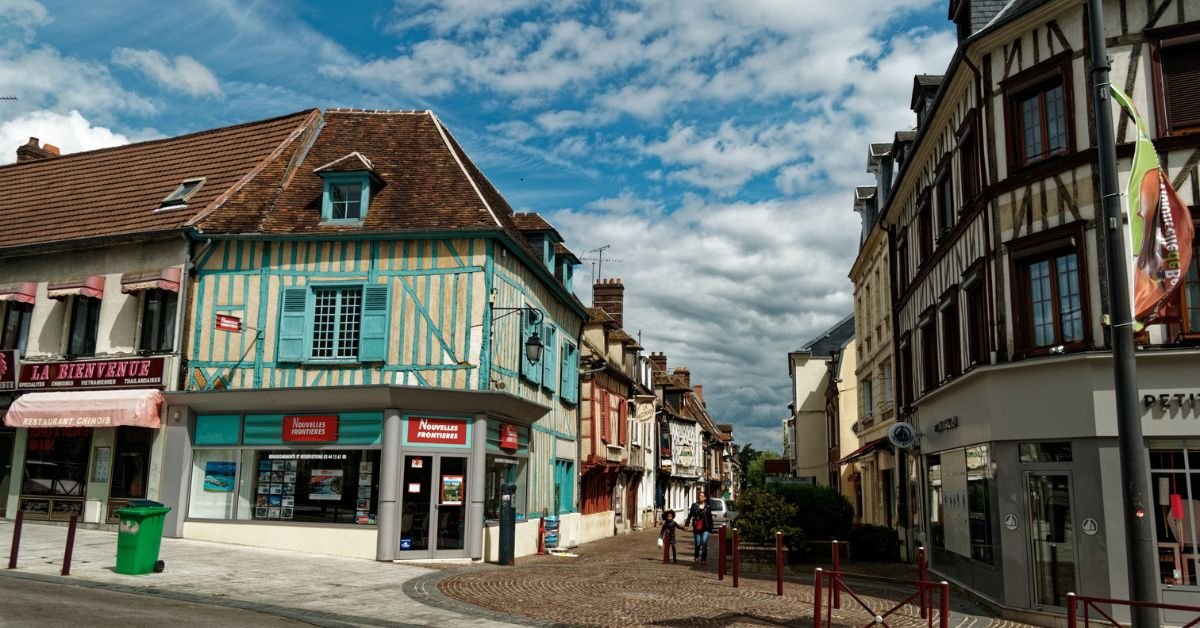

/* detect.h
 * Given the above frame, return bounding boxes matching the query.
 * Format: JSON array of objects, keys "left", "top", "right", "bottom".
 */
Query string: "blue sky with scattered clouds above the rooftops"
[{"left": 0, "top": 0, "right": 954, "bottom": 449}]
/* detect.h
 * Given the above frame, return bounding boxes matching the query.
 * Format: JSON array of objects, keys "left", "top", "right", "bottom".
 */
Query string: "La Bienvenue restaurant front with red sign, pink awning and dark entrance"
[{"left": 0, "top": 357, "right": 168, "bottom": 524}]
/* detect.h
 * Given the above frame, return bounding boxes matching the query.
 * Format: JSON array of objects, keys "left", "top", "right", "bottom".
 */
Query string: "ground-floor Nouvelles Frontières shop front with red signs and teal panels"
[{"left": 166, "top": 385, "right": 546, "bottom": 560}]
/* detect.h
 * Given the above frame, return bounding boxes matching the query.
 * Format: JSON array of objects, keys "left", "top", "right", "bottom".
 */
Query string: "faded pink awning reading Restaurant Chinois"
[{"left": 4, "top": 388, "right": 162, "bottom": 427}]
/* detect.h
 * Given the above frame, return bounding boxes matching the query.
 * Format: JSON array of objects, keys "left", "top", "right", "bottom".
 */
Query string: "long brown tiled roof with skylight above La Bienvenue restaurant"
[{"left": 0, "top": 109, "right": 319, "bottom": 249}]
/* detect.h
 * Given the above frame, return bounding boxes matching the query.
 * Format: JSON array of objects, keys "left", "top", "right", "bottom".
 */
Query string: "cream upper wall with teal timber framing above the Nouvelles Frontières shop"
[{"left": 187, "top": 233, "right": 586, "bottom": 514}]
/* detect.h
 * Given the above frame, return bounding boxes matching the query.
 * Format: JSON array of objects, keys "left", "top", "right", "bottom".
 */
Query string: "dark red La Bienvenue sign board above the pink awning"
[{"left": 17, "top": 355, "right": 167, "bottom": 390}]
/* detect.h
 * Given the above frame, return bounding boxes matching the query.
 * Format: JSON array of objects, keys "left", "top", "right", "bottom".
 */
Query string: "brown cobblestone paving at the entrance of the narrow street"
[{"left": 424, "top": 530, "right": 1041, "bottom": 628}]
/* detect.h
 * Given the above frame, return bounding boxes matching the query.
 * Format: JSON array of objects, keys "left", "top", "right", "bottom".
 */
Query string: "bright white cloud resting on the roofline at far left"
[{"left": 0, "top": 110, "right": 130, "bottom": 163}]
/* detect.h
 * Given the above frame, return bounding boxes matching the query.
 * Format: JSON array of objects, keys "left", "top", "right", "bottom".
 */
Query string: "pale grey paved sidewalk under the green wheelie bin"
[{"left": 0, "top": 521, "right": 523, "bottom": 627}]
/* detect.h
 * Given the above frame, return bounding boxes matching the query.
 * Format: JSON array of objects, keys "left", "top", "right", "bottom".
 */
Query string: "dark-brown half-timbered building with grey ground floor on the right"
[{"left": 881, "top": 0, "right": 1200, "bottom": 612}]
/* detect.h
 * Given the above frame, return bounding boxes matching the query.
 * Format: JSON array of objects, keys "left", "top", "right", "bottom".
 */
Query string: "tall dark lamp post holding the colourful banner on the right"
[{"left": 1087, "top": 0, "right": 1159, "bottom": 628}]
